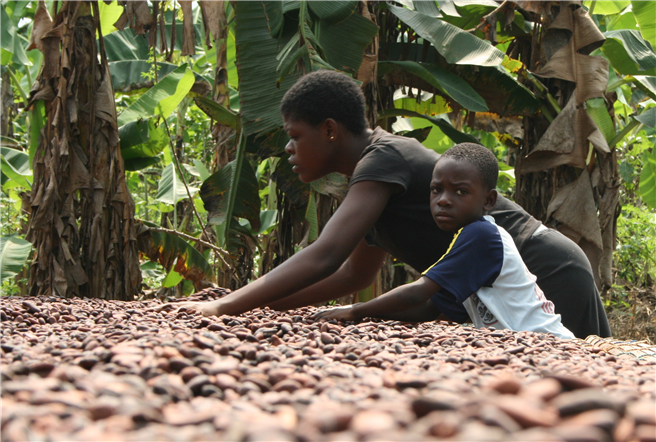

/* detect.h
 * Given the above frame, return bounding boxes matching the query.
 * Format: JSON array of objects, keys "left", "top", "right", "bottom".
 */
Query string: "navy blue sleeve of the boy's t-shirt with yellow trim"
[{"left": 424, "top": 218, "right": 503, "bottom": 304}]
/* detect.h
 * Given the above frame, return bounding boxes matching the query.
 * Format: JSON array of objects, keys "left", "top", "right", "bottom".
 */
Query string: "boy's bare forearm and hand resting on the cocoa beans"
[{"left": 315, "top": 276, "right": 440, "bottom": 321}]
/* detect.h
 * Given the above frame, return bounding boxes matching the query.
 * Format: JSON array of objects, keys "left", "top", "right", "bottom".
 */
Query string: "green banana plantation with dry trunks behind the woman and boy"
[{"left": 0, "top": 0, "right": 656, "bottom": 342}]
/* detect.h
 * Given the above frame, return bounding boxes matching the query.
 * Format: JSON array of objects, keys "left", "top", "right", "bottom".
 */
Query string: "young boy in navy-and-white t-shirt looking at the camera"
[{"left": 315, "top": 143, "right": 574, "bottom": 339}]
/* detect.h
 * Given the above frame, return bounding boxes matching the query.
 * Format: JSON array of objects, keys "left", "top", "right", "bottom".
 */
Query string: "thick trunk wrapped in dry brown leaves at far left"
[{"left": 28, "top": 0, "right": 141, "bottom": 300}]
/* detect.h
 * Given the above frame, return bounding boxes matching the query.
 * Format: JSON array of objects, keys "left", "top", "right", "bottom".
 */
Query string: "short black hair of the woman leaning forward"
[{"left": 280, "top": 70, "right": 368, "bottom": 135}]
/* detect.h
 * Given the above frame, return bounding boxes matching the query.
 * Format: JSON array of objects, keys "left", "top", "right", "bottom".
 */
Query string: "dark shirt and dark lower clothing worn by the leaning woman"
[{"left": 349, "top": 128, "right": 610, "bottom": 337}]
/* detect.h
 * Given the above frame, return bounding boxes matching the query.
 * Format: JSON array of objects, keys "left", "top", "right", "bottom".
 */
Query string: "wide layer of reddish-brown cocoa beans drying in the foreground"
[{"left": 0, "top": 297, "right": 656, "bottom": 442}]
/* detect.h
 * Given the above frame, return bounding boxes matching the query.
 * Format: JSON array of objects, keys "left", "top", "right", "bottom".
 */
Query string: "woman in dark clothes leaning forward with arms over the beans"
[{"left": 165, "top": 71, "right": 610, "bottom": 337}]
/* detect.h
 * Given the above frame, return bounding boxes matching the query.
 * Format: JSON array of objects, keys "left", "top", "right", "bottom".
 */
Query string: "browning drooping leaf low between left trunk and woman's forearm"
[{"left": 137, "top": 222, "right": 212, "bottom": 282}]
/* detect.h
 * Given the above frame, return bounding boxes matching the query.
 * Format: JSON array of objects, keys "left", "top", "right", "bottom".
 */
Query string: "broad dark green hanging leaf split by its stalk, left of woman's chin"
[{"left": 200, "top": 160, "right": 260, "bottom": 231}]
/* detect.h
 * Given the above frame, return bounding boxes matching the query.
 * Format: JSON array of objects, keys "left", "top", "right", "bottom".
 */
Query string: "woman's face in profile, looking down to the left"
[{"left": 283, "top": 117, "right": 333, "bottom": 183}]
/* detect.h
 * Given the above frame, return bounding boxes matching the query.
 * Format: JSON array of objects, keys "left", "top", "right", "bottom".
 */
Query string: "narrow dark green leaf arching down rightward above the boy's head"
[{"left": 378, "top": 61, "right": 488, "bottom": 112}]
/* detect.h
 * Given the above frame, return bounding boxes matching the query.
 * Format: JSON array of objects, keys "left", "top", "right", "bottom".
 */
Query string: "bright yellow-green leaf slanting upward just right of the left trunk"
[{"left": 118, "top": 63, "right": 194, "bottom": 126}]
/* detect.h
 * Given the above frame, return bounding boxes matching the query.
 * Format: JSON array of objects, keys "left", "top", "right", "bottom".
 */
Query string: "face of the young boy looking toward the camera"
[{"left": 430, "top": 157, "right": 497, "bottom": 232}]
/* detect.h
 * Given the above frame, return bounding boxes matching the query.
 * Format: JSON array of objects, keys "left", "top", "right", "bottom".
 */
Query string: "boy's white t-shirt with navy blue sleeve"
[{"left": 423, "top": 216, "right": 574, "bottom": 339}]
